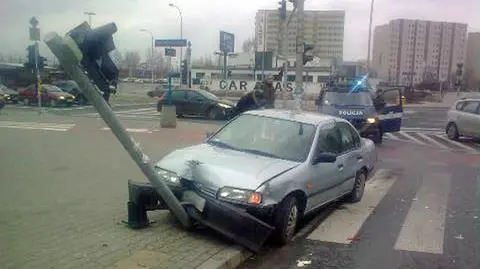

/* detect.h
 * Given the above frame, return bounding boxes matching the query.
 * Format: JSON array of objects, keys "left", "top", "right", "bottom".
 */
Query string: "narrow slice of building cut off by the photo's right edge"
[{"left": 464, "top": 33, "right": 480, "bottom": 88}]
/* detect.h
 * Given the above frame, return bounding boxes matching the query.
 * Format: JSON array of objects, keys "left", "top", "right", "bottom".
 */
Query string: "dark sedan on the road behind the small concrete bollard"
[{"left": 157, "top": 89, "right": 235, "bottom": 120}]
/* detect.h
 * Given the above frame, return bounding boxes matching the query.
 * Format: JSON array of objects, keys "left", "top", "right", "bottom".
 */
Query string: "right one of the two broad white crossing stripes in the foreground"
[{"left": 394, "top": 173, "right": 451, "bottom": 254}]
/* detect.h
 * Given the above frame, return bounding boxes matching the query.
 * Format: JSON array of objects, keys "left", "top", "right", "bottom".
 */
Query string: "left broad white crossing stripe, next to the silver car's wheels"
[{"left": 308, "top": 169, "right": 396, "bottom": 244}]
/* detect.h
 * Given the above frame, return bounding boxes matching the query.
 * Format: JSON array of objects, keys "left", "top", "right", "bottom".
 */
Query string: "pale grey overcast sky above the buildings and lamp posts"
[{"left": 0, "top": 0, "right": 480, "bottom": 60}]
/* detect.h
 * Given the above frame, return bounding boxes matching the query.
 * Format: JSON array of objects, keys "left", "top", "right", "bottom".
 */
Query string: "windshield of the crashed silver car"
[{"left": 207, "top": 114, "right": 316, "bottom": 162}]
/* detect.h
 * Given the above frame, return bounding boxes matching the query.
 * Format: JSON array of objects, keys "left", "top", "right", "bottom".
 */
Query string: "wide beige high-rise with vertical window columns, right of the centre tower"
[{"left": 371, "top": 19, "right": 467, "bottom": 85}]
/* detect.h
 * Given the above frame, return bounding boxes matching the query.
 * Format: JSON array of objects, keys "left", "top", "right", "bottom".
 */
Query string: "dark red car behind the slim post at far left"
[{"left": 18, "top": 84, "right": 75, "bottom": 107}]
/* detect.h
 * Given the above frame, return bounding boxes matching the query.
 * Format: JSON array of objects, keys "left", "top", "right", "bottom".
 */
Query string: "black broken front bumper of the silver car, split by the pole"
[{"left": 127, "top": 181, "right": 274, "bottom": 252}]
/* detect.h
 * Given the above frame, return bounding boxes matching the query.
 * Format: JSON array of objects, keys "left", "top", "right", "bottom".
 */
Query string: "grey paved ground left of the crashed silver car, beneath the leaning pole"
[{"left": 0, "top": 109, "right": 234, "bottom": 269}]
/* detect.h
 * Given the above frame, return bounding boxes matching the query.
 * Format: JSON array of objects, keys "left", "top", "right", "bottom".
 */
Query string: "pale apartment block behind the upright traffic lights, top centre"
[{"left": 255, "top": 9, "right": 345, "bottom": 60}]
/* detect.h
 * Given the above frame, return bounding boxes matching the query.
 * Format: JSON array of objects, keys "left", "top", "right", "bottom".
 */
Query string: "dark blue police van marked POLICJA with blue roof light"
[{"left": 316, "top": 79, "right": 403, "bottom": 144}]
